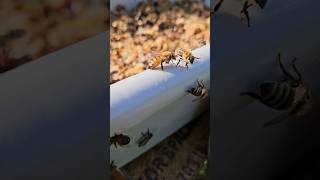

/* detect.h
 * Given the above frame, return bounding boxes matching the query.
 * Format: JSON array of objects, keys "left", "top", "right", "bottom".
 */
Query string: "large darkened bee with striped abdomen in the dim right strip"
[{"left": 241, "top": 53, "right": 312, "bottom": 124}]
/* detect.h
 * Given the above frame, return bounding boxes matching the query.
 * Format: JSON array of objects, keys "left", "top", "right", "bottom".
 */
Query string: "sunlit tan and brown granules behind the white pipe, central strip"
[{"left": 110, "top": 0, "right": 210, "bottom": 84}]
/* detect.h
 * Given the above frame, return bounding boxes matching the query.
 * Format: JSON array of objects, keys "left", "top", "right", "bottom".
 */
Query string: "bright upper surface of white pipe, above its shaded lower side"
[{"left": 110, "top": 45, "right": 210, "bottom": 135}]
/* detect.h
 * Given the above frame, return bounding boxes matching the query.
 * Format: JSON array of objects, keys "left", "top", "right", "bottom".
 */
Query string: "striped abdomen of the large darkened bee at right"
[{"left": 260, "top": 82, "right": 295, "bottom": 110}]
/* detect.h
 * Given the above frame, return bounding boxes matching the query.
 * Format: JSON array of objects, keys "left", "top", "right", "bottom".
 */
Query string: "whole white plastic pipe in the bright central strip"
[{"left": 110, "top": 45, "right": 210, "bottom": 167}]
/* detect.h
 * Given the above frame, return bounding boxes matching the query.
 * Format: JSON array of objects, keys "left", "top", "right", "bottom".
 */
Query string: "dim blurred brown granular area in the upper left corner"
[{"left": 0, "top": 0, "right": 109, "bottom": 73}]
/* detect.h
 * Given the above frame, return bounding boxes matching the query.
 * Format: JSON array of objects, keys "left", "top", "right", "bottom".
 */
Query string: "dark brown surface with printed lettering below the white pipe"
[{"left": 122, "top": 112, "right": 210, "bottom": 180}]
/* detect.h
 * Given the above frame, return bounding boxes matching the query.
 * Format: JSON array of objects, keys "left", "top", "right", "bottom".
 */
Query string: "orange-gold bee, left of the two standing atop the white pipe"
[{"left": 149, "top": 51, "right": 176, "bottom": 71}]
